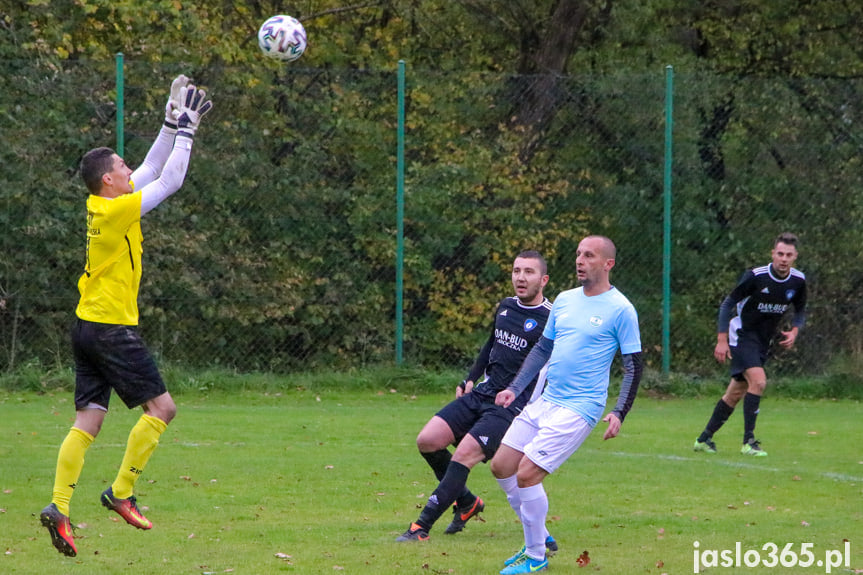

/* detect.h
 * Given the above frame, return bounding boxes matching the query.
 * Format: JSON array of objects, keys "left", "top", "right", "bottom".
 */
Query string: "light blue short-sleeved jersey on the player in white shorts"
[{"left": 542, "top": 287, "right": 641, "bottom": 427}]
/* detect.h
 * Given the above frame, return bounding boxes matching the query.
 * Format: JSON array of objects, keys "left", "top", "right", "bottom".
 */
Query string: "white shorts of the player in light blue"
[{"left": 502, "top": 397, "right": 593, "bottom": 473}]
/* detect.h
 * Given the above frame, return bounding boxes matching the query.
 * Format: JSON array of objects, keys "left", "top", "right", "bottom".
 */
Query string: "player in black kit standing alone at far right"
[{"left": 695, "top": 233, "right": 806, "bottom": 457}]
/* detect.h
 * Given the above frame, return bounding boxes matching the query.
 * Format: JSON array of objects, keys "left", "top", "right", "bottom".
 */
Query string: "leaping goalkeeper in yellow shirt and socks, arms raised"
[{"left": 40, "top": 75, "right": 213, "bottom": 557}]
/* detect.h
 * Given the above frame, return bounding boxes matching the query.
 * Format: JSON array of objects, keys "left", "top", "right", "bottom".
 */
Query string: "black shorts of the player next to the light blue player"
[{"left": 436, "top": 393, "right": 518, "bottom": 461}]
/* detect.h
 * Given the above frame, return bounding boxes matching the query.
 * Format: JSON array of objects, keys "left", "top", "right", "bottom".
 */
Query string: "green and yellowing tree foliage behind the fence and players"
[{"left": 0, "top": 0, "right": 863, "bottom": 377}]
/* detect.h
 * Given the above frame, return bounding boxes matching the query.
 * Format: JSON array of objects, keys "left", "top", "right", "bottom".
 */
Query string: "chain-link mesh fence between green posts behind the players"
[{"left": 0, "top": 61, "right": 863, "bottom": 373}]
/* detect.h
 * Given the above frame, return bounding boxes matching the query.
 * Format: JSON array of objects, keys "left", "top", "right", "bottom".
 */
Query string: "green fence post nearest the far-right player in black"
[{"left": 662, "top": 66, "right": 674, "bottom": 376}]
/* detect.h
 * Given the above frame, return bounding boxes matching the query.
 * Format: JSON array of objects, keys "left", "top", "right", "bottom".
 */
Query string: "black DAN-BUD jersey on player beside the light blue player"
[{"left": 467, "top": 297, "right": 551, "bottom": 405}]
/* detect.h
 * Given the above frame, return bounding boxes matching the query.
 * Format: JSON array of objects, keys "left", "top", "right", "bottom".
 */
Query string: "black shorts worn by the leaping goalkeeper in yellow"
[{"left": 72, "top": 319, "right": 168, "bottom": 410}]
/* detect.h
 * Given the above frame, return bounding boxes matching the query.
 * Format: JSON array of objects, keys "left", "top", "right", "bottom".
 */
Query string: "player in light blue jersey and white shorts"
[{"left": 491, "top": 236, "right": 641, "bottom": 575}]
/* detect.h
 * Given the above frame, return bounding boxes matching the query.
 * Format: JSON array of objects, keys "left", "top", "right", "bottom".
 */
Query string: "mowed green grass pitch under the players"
[{"left": 0, "top": 391, "right": 863, "bottom": 575}]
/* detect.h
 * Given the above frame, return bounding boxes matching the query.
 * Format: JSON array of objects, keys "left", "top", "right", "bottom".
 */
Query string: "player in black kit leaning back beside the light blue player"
[{"left": 396, "top": 251, "right": 556, "bottom": 548}]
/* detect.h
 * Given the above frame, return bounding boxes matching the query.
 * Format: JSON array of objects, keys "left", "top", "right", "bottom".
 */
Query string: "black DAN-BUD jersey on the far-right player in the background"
[{"left": 728, "top": 265, "right": 806, "bottom": 346}]
